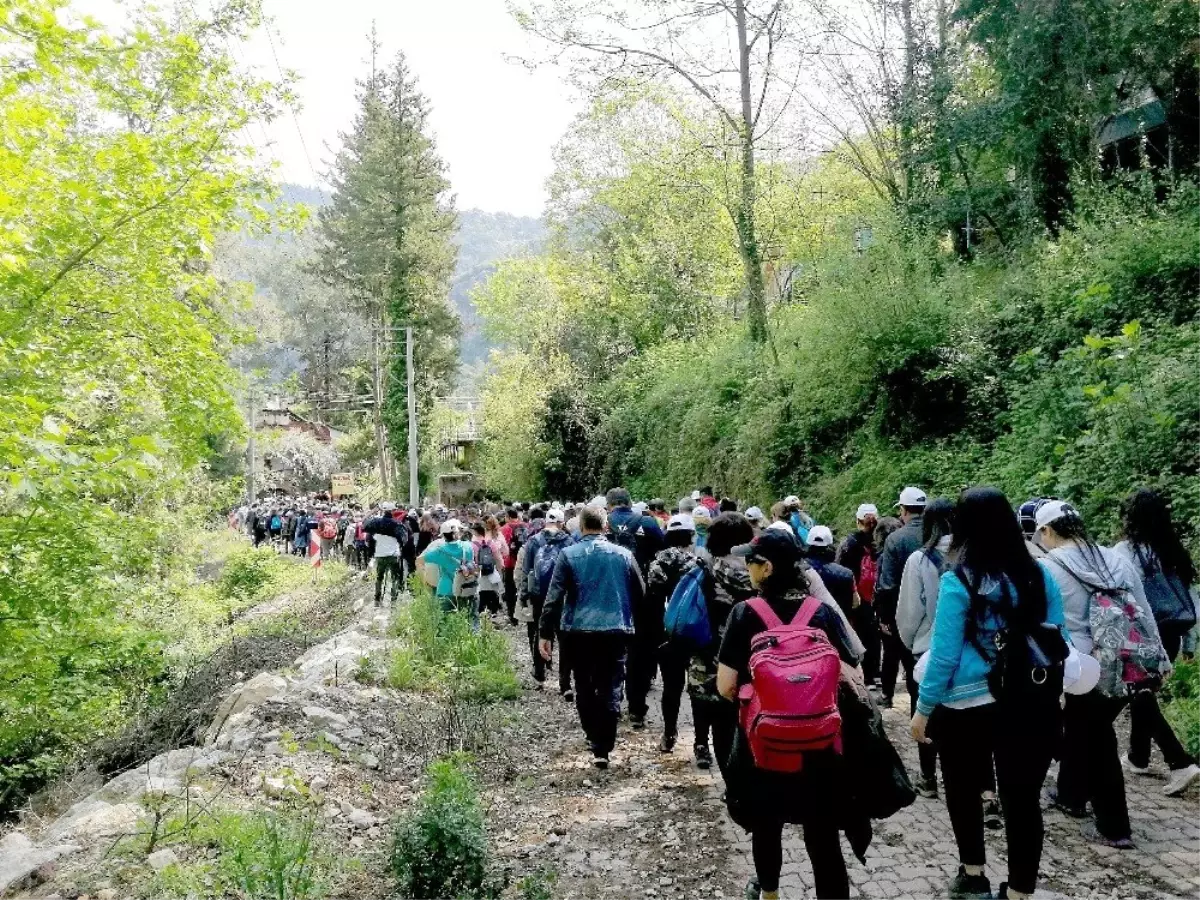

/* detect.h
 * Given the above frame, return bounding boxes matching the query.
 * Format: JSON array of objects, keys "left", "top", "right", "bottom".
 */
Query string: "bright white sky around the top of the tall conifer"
[{"left": 78, "top": 0, "right": 577, "bottom": 216}]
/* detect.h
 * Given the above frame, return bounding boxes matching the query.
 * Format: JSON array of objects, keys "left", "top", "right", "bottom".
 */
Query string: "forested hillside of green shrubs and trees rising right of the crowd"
[{"left": 476, "top": 0, "right": 1200, "bottom": 547}]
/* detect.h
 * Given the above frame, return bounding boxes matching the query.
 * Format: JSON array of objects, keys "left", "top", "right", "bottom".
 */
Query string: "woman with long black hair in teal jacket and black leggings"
[{"left": 912, "top": 487, "right": 1066, "bottom": 900}]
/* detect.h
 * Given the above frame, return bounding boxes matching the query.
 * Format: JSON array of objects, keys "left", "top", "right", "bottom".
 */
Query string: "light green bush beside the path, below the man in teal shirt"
[{"left": 388, "top": 578, "right": 521, "bottom": 703}]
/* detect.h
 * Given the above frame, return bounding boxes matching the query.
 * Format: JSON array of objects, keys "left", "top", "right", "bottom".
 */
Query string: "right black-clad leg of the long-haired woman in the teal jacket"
[{"left": 992, "top": 716, "right": 1052, "bottom": 894}]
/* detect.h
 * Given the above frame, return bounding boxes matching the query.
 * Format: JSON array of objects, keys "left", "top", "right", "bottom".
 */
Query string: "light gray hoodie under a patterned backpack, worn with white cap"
[{"left": 1043, "top": 545, "right": 1162, "bottom": 653}]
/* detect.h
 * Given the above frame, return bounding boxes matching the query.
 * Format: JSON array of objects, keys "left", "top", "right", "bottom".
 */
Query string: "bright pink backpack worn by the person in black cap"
[{"left": 739, "top": 596, "right": 841, "bottom": 773}]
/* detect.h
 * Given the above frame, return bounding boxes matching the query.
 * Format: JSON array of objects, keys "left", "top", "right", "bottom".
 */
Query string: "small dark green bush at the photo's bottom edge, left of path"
[{"left": 391, "top": 757, "right": 502, "bottom": 900}]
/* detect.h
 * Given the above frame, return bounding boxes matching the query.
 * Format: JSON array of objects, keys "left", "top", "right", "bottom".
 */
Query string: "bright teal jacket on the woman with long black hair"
[{"left": 917, "top": 563, "right": 1068, "bottom": 715}]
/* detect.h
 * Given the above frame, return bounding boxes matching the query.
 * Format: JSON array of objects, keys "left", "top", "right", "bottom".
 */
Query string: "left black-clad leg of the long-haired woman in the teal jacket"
[{"left": 934, "top": 707, "right": 991, "bottom": 875}]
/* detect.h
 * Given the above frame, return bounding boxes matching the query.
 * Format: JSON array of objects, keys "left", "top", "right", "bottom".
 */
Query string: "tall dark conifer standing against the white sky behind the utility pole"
[{"left": 319, "top": 31, "right": 462, "bottom": 494}]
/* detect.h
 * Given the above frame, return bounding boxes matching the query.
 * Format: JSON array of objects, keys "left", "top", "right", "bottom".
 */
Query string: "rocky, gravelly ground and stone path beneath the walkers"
[{"left": 0, "top": 586, "right": 1200, "bottom": 900}]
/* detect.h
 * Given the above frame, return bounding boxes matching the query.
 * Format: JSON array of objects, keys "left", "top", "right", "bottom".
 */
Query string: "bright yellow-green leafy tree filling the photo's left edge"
[{"left": 0, "top": 0, "right": 283, "bottom": 806}]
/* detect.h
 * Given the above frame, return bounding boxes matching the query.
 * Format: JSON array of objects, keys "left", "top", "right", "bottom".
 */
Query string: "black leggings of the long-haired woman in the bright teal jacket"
[{"left": 934, "top": 703, "right": 1055, "bottom": 894}]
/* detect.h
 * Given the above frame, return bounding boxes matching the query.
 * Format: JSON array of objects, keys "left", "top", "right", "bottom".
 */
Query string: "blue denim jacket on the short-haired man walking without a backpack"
[{"left": 540, "top": 534, "right": 646, "bottom": 640}]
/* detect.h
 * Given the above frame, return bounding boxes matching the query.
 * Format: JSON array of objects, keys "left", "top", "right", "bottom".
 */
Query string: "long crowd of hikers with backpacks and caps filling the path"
[{"left": 229, "top": 487, "right": 1200, "bottom": 900}]
